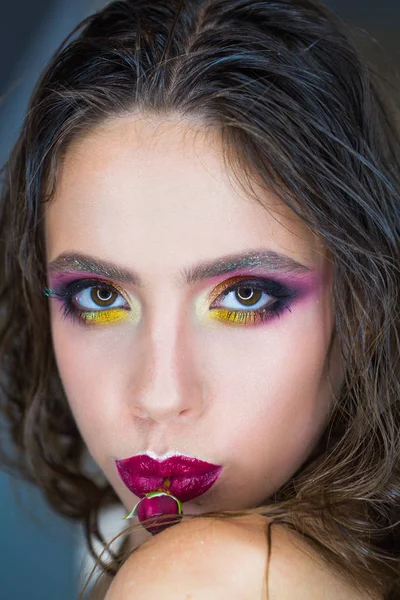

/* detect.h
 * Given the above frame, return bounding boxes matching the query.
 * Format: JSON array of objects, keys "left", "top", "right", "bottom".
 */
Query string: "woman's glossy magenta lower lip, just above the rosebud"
[{"left": 119, "top": 467, "right": 222, "bottom": 502}]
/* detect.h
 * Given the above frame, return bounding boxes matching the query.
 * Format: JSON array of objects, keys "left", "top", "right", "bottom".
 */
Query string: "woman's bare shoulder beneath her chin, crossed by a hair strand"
[{"left": 106, "top": 515, "right": 378, "bottom": 600}]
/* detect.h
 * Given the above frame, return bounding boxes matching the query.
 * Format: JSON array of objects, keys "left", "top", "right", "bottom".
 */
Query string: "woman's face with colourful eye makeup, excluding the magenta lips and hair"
[{"left": 45, "top": 117, "right": 342, "bottom": 528}]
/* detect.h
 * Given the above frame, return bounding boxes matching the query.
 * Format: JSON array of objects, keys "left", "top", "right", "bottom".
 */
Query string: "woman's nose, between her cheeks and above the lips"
[{"left": 128, "top": 312, "right": 205, "bottom": 423}]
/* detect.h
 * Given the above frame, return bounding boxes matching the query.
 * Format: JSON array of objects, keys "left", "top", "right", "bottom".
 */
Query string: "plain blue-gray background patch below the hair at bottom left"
[{"left": 0, "top": 474, "right": 77, "bottom": 600}]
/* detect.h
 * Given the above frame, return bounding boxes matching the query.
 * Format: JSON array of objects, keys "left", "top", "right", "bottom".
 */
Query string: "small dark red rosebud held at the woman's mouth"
[{"left": 124, "top": 478, "right": 182, "bottom": 535}]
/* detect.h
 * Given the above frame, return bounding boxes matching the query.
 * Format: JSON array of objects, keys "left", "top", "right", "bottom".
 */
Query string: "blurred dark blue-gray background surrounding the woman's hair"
[{"left": 0, "top": 0, "right": 400, "bottom": 600}]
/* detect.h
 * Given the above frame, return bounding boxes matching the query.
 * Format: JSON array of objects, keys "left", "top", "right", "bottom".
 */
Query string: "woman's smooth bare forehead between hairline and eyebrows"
[{"left": 45, "top": 116, "right": 324, "bottom": 274}]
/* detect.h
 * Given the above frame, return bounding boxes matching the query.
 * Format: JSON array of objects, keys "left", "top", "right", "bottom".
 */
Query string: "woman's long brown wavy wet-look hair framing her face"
[{"left": 0, "top": 0, "right": 400, "bottom": 600}]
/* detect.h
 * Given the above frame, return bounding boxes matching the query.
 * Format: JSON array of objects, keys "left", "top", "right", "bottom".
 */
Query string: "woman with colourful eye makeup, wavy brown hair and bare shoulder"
[{"left": 0, "top": 0, "right": 400, "bottom": 600}]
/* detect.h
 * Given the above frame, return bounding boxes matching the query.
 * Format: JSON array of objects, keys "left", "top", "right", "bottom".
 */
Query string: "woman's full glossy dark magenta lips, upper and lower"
[{"left": 116, "top": 454, "right": 222, "bottom": 502}]
